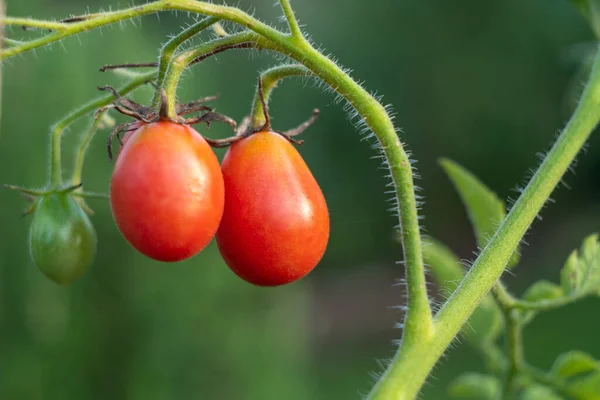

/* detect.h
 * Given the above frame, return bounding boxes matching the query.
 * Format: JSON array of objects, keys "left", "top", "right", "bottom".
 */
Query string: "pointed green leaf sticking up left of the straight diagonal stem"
[{"left": 440, "top": 159, "right": 519, "bottom": 268}]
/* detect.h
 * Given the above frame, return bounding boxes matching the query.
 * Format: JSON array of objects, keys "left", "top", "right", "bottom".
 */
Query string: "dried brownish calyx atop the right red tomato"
[{"left": 205, "top": 76, "right": 321, "bottom": 148}]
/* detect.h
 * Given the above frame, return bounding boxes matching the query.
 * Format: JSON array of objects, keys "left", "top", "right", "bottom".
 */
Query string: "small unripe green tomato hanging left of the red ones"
[{"left": 29, "top": 193, "right": 97, "bottom": 285}]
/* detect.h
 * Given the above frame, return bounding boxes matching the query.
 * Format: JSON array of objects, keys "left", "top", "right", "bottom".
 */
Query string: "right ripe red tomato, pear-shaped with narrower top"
[{"left": 217, "top": 132, "right": 329, "bottom": 286}]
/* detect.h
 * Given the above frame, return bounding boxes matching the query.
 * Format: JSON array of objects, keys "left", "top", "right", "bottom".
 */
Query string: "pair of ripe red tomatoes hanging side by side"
[{"left": 110, "top": 121, "right": 329, "bottom": 286}]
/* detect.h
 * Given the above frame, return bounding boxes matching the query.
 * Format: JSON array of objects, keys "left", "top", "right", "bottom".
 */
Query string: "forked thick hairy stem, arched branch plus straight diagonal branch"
[{"left": 0, "top": 0, "right": 600, "bottom": 400}]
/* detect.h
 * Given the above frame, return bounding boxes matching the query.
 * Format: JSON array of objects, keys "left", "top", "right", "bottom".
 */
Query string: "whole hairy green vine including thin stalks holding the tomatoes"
[{"left": 0, "top": 0, "right": 600, "bottom": 400}]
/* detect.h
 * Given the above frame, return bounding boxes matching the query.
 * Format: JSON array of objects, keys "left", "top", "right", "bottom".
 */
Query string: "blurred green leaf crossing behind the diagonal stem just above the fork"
[{"left": 423, "top": 239, "right": 504, "bottom": 345}]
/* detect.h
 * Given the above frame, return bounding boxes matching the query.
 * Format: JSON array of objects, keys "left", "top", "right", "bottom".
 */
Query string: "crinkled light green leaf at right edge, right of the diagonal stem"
[{"left": 560, "top": 234, "right": 600, "bottom": 296}]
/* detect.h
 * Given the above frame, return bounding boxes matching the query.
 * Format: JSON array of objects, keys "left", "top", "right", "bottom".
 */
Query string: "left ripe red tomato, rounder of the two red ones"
[{"left": 110, "top": 122, "right": 225, "bottom": 262}]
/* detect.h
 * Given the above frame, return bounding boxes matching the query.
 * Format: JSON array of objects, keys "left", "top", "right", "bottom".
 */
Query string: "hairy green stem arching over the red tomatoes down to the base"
[{"left": 7, "top": 0, "right": 432, "bottom": 399}]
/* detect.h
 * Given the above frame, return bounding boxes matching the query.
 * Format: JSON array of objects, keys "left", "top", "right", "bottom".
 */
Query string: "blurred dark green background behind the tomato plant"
[{"left": 0, "top": 0, "right": 600, "bottom": 400}]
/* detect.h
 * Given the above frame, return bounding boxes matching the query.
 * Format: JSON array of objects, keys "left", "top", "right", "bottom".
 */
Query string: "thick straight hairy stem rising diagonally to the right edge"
[{"left": 373, "top": 47, "right": 600, "bottom": 399}]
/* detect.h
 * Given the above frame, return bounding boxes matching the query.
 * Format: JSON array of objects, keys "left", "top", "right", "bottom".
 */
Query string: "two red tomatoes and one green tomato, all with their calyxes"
[{"left": 9, "top": 86, "right": 329, "bottom": 286}]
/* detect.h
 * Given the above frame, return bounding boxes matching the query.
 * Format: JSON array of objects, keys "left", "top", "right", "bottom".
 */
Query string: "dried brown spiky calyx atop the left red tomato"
[{"left": 96, "top": 86, "right": 237, "bottom": 160}]
